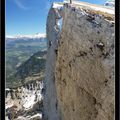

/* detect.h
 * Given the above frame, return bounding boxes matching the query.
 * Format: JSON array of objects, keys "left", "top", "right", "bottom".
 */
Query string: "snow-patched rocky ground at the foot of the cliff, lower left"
[{"left": 5, "top": 81, "right": 43, "bottom": 120}]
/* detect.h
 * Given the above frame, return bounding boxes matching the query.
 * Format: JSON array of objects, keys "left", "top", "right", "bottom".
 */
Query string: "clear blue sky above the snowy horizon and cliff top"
[{"left": 5, "top": 0, "right": 106, "bottom": 35}]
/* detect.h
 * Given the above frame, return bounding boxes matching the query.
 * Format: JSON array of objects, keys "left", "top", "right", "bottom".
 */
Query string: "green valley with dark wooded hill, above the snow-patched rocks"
[{"left": 6, "top": 40, "right": 46, "bottom": 87}]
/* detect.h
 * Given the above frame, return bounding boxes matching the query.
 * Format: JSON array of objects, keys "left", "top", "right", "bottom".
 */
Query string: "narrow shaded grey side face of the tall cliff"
[{"left": 43, "top": 3, "right": 60, "bottom": 120}]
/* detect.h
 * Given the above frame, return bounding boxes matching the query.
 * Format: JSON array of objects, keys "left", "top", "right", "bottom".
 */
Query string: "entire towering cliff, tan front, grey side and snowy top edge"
[{"left": 44, "top": 3, "right": 114, "bottom": 120}]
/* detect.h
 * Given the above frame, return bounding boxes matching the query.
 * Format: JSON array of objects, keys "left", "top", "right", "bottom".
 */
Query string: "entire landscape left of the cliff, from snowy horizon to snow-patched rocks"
[{"left": 5, "top": 35, "right": 47, "bottom": 120}]
